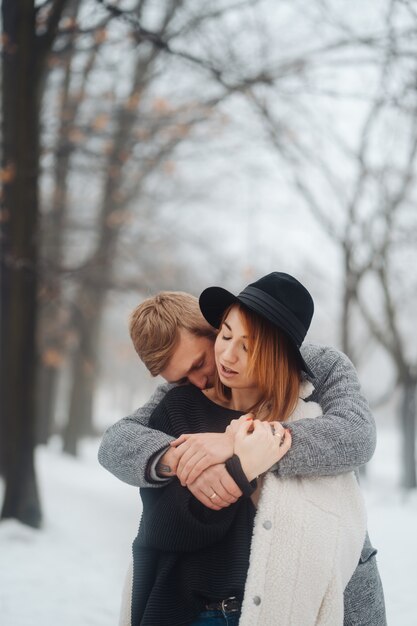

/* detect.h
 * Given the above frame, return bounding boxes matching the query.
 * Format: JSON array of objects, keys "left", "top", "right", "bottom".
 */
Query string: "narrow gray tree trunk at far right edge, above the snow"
[{"left": 401, "top": 379, "right": 417, "bottom": 489}]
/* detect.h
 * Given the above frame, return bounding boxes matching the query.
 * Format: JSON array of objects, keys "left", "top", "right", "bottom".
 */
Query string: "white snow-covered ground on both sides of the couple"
[{"left": 0, "top": 433, "right": 417, "bottom": 626}]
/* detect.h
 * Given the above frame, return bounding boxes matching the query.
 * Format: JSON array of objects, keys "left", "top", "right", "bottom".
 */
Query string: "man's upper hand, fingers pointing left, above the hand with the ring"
[{"left": 171, "top": 432, "right": 234, "bottom": 486}]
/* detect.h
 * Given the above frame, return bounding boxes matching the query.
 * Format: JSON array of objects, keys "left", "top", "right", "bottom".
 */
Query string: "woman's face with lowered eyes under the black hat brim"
[{"left": 214, "top": 307, "right": 256, "bottom": 389}]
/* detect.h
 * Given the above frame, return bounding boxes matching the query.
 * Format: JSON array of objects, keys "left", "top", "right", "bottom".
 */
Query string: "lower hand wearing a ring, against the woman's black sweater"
[{"left": 187, "top": 463, "right": 242, "bottom": 511}]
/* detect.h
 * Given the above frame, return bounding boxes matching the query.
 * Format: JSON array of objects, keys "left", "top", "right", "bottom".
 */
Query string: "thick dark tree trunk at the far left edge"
[{"left": 0, "top": 0, "right": 41, "bottom": 527}]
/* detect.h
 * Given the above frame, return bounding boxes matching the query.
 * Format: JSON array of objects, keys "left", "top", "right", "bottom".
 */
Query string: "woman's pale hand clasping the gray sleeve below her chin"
[{"left": 233, "top": 417, "right": 291, "bottom": 481}]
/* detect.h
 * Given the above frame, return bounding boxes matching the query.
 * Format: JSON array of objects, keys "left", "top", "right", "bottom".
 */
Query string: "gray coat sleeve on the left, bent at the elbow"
[{"left": 98, "top": 384, "right": 173, "bottom": 487}]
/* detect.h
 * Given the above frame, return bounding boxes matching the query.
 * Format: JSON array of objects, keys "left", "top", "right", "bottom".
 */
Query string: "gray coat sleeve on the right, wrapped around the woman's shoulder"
[{"left": 274, "top": 345, "right": 376, "bottom": 476}]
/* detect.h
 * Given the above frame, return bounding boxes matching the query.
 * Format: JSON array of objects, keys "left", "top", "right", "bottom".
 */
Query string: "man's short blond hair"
[{"left": 129, "top": 291, "right": 216, "bottom": 376}]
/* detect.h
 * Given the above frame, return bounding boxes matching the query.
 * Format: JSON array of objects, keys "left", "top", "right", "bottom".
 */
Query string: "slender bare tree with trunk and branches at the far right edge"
[{"left": 355, "top": 132, "right": 417, "bottom": 489}]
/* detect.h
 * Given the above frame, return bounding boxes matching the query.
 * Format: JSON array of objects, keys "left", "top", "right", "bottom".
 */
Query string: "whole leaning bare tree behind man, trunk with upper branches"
[{"left": 37, "top": 0, "right": 274, "bottom": 454}]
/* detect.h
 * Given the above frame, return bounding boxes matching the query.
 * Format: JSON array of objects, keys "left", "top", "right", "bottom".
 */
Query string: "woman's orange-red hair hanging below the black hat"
[{"left": 215, "top": 304, "right": 301, "bottom": 422}]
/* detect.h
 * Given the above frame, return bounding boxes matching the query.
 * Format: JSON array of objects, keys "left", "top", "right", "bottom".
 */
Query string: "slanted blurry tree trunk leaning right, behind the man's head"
[{"left": 60, "top": 2, "right": 179, "bottom": 454}]
